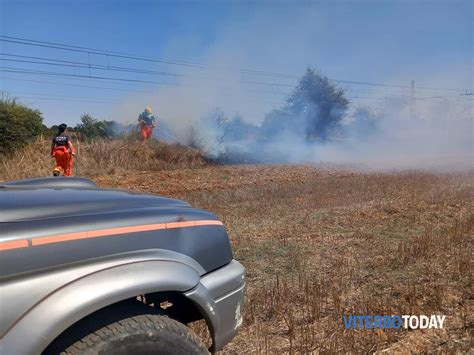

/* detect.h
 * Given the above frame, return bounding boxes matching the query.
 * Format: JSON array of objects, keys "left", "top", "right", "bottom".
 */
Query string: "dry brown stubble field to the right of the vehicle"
[{"left": 94, "top": 165, "right": 474, "bottom": 354}]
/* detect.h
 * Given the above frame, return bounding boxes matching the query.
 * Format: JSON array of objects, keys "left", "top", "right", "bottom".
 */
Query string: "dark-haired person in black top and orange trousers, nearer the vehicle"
[{"left": 51, "top": 123, "right": 76, "bottom": 176}]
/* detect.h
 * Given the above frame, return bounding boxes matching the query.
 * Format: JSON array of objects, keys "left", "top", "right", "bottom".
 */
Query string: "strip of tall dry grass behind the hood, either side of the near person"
[{"left": 0, "top": 137, "right": 204, "bottom": 180}]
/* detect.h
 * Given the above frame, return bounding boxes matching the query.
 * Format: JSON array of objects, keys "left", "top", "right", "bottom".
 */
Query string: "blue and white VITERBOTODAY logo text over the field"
[{"left": 342, "top": 314, "right": 446, "bottom": 329}]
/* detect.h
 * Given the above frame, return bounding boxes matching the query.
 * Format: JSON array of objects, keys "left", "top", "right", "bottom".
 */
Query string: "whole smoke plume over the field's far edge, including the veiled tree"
[{"left": 114, "top": 7, "right": 474, "bottom": 169}]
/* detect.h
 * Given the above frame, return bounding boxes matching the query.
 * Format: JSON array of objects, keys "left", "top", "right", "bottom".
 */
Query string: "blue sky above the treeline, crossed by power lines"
[{"left": 0, "top": 0, "right": 474, "bottom": 125}]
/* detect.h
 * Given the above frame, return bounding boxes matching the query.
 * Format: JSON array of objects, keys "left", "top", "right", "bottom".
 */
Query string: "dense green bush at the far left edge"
[{"left": 0, "top": 99, "right": 46, "bottom": 155}]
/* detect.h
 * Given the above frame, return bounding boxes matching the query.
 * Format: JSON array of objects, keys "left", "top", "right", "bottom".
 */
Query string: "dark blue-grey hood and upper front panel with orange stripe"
[{"left": 0, "top": 178, "right": 232, "bottom": 279}]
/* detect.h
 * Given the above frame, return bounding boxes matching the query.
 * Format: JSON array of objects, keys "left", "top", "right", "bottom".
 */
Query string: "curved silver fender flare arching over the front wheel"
[{"left": 0, "top": 260, "right": 200, "bottom": 354}]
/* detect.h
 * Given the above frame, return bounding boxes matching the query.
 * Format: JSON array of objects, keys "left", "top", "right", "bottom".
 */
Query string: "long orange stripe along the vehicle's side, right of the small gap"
[{"left": 31, "top": 220, "right": 222, "bottom": 246}]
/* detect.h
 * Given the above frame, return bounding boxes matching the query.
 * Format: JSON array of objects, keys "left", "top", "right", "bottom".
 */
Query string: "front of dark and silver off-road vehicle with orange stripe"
[{"left": 0, "top": 178, "right": 245, "bottom": 354}]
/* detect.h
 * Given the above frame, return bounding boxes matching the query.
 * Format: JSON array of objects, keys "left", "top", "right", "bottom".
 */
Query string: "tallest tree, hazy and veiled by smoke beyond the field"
[{"left": 262, "top": 68, "right": 349, "bottom": 141}]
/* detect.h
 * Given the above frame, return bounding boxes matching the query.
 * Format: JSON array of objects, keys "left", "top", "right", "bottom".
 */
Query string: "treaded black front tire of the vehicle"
[{"left": 62, "top": 314, "right": 209, "bottom": 355}]
